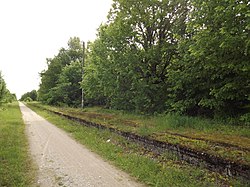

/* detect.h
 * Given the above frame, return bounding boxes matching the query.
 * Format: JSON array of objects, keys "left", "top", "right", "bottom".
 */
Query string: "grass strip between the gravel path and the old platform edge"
[{"left": 26, "top": 105, "right": 248, "bottom": 187}]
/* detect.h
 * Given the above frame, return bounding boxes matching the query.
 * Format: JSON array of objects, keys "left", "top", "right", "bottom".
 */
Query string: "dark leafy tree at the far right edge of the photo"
[{"left": 167, "top": 0, "right": 250, "bottom": 116}]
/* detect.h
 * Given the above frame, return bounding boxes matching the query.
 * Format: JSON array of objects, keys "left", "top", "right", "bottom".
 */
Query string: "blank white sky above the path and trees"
[{"left": 0, "top": 0, "right": 112, "bottom": 98}]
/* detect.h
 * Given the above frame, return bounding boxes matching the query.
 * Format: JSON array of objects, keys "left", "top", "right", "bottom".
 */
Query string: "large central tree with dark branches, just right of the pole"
[{"left": 83, "top": 0, "right": 187, "bottom": 113}]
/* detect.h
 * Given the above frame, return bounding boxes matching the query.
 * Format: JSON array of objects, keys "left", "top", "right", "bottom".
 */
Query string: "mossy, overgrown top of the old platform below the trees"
[{"left": 29, "top": 103, "right": 250, "bottom": 165}]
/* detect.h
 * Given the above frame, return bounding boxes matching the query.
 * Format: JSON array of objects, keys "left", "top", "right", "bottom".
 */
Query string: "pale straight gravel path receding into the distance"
[{"left": 19, "top": 103, "right": 142, "bottom": 187}]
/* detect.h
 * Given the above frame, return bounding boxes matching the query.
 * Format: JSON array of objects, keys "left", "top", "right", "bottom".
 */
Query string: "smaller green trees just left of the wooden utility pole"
[{"left": 38, "top": 37, "right": 82, "bottom": 106}]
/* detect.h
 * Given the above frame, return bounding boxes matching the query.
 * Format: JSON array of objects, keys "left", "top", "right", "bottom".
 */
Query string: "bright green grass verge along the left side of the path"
[{"left": 0, "top": 102, "right": 34, "bottom": 187}]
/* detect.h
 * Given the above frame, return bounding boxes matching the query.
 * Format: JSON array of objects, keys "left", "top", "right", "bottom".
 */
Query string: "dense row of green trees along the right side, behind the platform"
[{"left": 38, "top": 0, "right": 250, "bottom": 120}]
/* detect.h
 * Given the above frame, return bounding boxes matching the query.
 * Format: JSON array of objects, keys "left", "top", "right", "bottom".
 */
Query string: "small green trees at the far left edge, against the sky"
[{"left": 0, "top": 71, "right": 16, "bottom": 106}]
